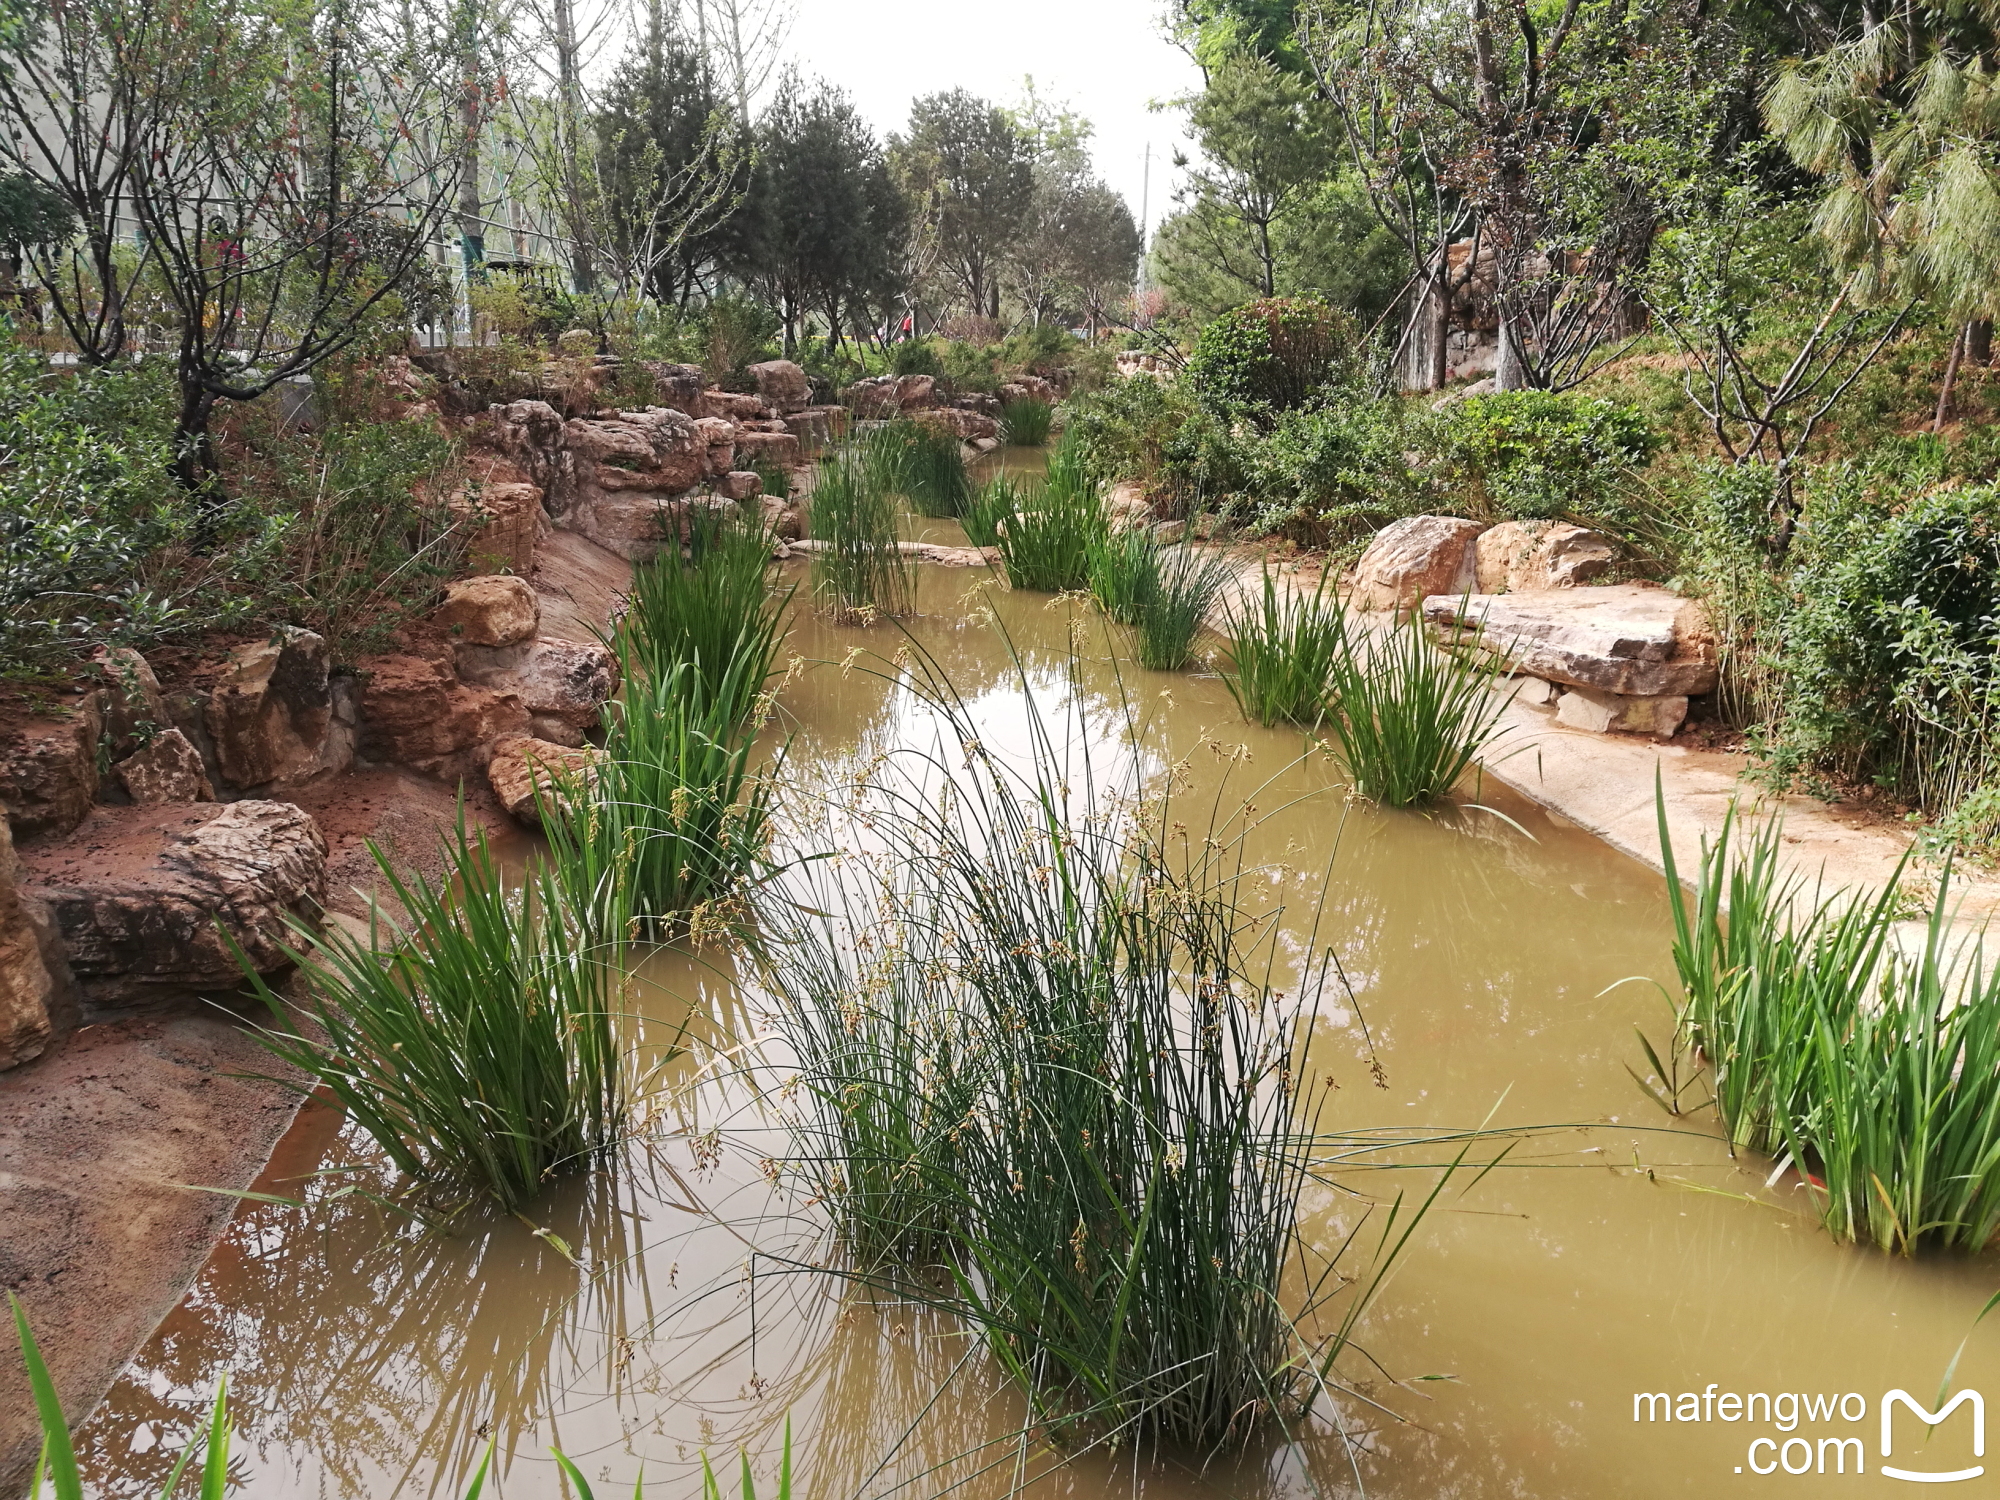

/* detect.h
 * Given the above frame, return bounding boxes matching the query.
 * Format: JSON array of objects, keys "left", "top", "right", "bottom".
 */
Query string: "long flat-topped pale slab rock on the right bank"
[{"left": 1424, "top": 584, "right": 1716, "bottom": 712}]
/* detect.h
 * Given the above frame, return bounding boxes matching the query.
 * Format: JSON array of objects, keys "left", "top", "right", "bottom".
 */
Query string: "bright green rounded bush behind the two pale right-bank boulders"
[{"left": 1430, "top": 390, "right": 1662, "bottom": 520}]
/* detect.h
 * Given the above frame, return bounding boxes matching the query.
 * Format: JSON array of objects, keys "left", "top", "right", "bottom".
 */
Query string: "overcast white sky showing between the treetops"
[{"left": 788, "top": 0, "right": 1202, "bottom": 244}]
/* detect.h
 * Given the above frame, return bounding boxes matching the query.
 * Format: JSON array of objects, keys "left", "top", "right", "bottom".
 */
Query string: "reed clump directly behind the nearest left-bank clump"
[{"left": 542, "top": 654, "right": 774, "bottom": 938}]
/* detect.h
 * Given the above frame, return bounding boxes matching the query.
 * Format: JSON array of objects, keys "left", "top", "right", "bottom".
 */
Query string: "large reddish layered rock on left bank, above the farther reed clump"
[{"left": 564, "top": 406, "right": 710, "bottom": 562}]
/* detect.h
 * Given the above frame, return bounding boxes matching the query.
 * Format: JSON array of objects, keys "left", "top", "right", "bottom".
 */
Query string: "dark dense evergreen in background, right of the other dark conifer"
[{"left": 750, "top": 74, "right": 904, "bottom": 354}]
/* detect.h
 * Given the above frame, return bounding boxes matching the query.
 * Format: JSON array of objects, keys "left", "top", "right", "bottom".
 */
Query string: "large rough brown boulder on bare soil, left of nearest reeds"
[{"left": 20, "top": 802, "right": 326, "bottom": 1010}]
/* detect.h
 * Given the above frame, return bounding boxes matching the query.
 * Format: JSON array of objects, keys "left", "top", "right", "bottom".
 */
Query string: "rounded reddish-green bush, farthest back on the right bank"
[{"left": 1182, "top": 298, "right": 1360, "bottom": 424}]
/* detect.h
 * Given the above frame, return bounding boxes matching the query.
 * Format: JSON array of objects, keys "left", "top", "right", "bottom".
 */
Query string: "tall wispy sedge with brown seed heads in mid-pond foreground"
[{"left": 758, "top": 656, "right": 1440, "bottom": 1448}]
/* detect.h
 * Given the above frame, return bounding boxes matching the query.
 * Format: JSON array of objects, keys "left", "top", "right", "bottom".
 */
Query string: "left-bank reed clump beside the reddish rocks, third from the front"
[{"left": 618, "top": 510, "right": 790, "bottom": 712}]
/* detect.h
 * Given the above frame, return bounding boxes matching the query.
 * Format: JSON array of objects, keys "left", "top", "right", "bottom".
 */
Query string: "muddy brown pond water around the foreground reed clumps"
[{"left": 80, "top": 570, "right": 2000, "bottom": 1500}]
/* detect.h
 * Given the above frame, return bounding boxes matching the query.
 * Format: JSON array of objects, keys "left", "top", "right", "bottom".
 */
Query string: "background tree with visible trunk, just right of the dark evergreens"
[{"left": 890, "top": 88, "right": 1034, "bottom": 318}]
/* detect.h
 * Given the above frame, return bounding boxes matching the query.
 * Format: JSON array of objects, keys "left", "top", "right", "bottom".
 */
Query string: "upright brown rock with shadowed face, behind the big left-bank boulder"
[{"left": 206, "top": 628, "right": 334, "bottom": 786}]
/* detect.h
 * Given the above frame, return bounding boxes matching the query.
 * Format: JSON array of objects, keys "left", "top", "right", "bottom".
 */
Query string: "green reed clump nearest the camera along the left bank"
[{"left": 246, "top": 814, "right": 630, "bottom": 1210}]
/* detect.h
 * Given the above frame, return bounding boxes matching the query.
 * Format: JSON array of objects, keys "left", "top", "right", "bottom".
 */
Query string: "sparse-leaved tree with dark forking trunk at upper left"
[{"left": 0, "top": 0, "right": 476, "bottom": 504}]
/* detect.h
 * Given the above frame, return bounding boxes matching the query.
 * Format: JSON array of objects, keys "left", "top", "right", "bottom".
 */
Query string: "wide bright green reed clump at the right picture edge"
[{"left": 1660, "top": 802, "right": 2000, "bottom": 1254}]
